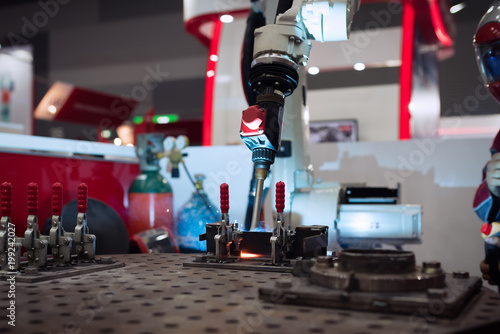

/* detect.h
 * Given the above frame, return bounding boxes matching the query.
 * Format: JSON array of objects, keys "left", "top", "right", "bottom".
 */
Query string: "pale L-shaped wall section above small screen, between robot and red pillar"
[{"left": 307, "top": 84, "right": 399, "bottom": 141}]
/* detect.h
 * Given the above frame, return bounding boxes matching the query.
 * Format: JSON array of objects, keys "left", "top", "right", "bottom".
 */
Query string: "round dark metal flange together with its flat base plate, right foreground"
[{"left": 259, "top": 249, "right": 482, "bottom": 317}]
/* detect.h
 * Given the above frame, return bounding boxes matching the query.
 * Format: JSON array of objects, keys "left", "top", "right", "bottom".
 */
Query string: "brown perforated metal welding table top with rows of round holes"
[{"left": 0, "top": 254, "right": 500, "bottom": 334}]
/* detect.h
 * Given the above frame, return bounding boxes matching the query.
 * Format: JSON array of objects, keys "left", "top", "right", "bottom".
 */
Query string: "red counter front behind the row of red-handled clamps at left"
[{"left": 0, "top": 152, "right": 140, "bottom": 236}]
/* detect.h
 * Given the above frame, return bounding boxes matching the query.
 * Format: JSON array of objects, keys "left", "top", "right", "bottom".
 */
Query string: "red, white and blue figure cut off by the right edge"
[{"left": 473, "top": 1, "right": 500, "bottom": 292}]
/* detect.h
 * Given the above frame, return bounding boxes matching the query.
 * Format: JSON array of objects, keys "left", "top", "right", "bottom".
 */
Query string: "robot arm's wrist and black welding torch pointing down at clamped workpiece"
[{"left": 240, "top": 0, "right": 359, "bottom": 228}]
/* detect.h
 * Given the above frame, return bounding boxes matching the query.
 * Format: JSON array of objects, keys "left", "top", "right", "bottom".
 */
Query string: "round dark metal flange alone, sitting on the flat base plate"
[{"left": 309, "top": 249, "right": 445, "bottom": 292}]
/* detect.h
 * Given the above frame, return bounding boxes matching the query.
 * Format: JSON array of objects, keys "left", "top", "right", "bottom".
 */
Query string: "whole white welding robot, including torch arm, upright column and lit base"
[{"left": 240, "top": 0, "right": 421, "bottom": 250}]
